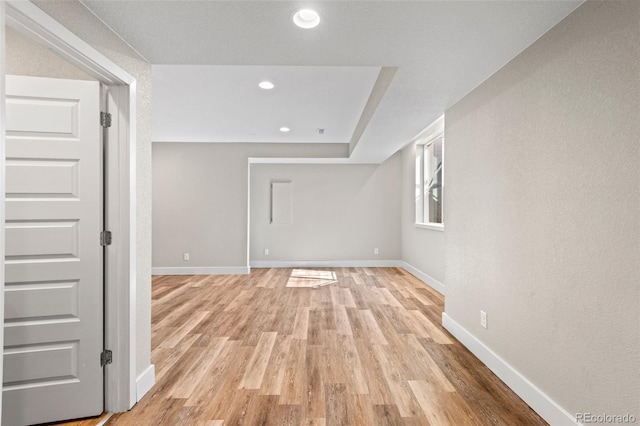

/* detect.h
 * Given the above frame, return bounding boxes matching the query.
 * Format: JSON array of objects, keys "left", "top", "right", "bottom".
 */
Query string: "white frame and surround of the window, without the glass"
[{"left": 413, "top": 115, "right": 445, "bottom": 231}]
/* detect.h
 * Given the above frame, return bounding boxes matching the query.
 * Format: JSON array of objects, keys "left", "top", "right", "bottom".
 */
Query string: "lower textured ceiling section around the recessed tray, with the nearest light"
[{"left": 84, "top": 0, "right": 581, "bottom": 162}]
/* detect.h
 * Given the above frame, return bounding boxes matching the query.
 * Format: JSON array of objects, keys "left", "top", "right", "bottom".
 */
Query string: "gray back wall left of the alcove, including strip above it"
[{"left": 153, "top": 143, "right": 348, "bottom": 268}]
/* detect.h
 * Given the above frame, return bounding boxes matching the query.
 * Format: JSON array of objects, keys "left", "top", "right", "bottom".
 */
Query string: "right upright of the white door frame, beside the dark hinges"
[{"left": 105, "top": 82, "right": 136, "bottom": 411}]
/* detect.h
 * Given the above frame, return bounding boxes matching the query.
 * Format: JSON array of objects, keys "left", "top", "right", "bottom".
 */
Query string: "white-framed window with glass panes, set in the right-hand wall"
[{"left": 415, "top": 116, "right": 444, "bottom": 230}]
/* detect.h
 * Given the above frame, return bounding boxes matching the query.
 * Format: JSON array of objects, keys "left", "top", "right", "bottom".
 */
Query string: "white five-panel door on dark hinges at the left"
[{"left": 2, "top": 76, "right": 103, "bottom": 426}]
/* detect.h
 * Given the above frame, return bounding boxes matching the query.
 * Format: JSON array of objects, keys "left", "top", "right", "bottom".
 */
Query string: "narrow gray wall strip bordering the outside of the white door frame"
[{"left": 33, "top": 0, "right": 151, "bottom": 380}]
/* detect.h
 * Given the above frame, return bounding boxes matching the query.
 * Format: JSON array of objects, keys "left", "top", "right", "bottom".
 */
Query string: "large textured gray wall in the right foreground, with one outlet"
[{"left": 445, "top": 1, "right": 640, "bottom": 417}]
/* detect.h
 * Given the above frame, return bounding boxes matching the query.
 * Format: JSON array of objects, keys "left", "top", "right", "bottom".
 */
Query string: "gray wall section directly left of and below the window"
[{"left": 400, "top": 141, "right": 448, "bottom": 285}]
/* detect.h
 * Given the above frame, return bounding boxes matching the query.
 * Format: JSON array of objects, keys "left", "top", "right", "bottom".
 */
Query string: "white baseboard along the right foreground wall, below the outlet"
[{"left": 442, "top": 313, "right": 580, "bottom": 426}]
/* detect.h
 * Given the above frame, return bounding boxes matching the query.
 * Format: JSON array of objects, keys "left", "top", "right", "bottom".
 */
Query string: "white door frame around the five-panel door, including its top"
[{"left": 0, "top": 0, "right": 137, "bottom": 413}]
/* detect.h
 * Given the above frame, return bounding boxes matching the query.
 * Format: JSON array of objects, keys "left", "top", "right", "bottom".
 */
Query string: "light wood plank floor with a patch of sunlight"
[{"left": 94, "top": 268, "right": 546, "bottom": 426}]
